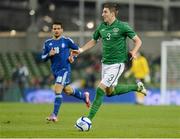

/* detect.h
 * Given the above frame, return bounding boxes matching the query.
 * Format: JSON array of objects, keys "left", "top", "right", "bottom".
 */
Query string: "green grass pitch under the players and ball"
[{"left": 0, "top": 103, "right": 180, "bottom": 138}]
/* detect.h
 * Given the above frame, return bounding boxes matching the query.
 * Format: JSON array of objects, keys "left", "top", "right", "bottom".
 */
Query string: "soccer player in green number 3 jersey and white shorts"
[{"left": 72, "top": 3, "right": 146, "bottom": 120}]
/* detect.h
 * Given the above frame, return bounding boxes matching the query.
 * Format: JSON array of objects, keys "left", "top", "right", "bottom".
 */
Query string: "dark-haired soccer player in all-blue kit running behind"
[{"left": 41, "top": 22, "right": 90, "bottom": 122}]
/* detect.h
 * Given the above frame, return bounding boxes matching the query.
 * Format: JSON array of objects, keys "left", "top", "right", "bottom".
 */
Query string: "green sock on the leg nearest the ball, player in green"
[{"left": 88, "top": 87, "right": 105, "bottom": 120}]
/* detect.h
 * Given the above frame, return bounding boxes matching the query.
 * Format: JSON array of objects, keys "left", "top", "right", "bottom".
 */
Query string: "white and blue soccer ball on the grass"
[{"left": 75, "top": 116, "right": 92, "bottom": 131}]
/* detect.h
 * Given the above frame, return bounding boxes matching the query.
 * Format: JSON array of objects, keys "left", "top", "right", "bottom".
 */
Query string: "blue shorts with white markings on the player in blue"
[{"left": 54, "top": 70, "right": 71, "bottom": 86}]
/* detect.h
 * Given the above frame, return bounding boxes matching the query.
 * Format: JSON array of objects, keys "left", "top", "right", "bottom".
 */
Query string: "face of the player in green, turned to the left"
[{"left": 102, "top": 8, "right": 114, "bottom": 23}]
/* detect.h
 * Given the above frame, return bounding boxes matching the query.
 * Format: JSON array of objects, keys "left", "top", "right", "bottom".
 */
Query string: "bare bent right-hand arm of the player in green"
[{"left": 130, "top": 35, "right": 142, "bottom": 58}]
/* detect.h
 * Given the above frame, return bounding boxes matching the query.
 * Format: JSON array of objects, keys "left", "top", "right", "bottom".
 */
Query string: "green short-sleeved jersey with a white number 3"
[{"left": 93, "top": 19, "right": 136, "bottom": 64}]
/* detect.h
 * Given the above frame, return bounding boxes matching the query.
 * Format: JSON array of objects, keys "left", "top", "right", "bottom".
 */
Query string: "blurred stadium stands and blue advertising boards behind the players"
[{"left": 0, "top": 0, "right": 180, "bottom": 105}]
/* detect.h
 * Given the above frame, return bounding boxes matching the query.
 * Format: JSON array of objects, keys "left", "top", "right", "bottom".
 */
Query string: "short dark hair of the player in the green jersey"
[{"left": 103, "top": 2, "right": 119, "bottom": 16}]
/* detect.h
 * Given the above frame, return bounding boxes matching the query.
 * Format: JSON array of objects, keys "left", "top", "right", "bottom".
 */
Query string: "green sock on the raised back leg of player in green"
[{"left": 110, "top": 84, "right": 138, "bottom": 97}]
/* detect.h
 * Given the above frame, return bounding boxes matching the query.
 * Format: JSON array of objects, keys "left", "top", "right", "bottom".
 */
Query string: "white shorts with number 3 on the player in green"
[{"left": 101, "top": 63, "right": 125, "bottom": 87}]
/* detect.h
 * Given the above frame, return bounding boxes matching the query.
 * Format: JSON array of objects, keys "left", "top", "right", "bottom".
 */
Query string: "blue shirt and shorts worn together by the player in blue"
[{"left": 41, "top": 36, "right": 78, "bottom": 85}]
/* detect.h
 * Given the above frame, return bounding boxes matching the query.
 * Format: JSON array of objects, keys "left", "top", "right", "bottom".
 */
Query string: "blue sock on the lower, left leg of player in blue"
[{"left": 53, "top": 94, "right": 62, "bottom": 116}]
